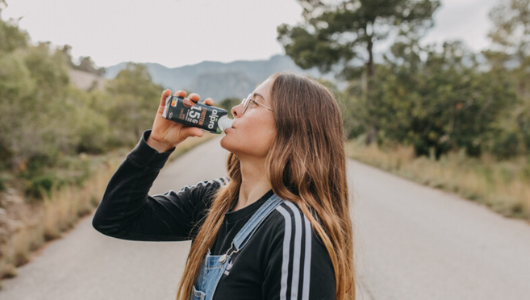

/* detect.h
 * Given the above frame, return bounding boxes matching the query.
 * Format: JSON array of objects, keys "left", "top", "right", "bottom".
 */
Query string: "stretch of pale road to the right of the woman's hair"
[{"left": 349, "top": 158, "right": 530, "bottom": 300}]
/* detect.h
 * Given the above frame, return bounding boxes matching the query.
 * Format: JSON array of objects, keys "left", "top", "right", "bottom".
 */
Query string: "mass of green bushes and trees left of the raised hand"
[{"left": 0, "top": 11, "right": 162, "bottom": 198}]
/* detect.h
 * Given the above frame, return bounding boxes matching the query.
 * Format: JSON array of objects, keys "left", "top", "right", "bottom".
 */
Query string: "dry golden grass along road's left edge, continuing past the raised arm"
[{"left": 0, "top": 133, "right": 218, "bottom": 287}]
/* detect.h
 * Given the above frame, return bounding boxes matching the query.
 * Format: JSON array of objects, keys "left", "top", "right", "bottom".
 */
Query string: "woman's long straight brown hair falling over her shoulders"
[{"left": 177, "top": 72, "right": 355, "bottom": 300}]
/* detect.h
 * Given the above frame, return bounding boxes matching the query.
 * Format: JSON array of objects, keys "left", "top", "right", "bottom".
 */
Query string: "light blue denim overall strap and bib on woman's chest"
[{"left": 190, "top": 195, "right": 285, "bottom": 300}]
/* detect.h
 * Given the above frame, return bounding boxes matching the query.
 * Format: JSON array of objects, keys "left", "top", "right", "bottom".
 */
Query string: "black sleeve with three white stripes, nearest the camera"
[{"left": 262, "top": 205, "right": 335, "bottom": 300}]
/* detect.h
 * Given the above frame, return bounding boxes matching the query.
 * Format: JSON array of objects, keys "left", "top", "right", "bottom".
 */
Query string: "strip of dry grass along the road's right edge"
[{"left": 346, "top": 141, "right": 530, "bottom": 219}]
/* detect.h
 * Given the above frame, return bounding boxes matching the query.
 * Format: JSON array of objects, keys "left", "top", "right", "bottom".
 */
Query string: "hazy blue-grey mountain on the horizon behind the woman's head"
[{"left": 105, "top": 55, "right": 332, "bottom": 101}]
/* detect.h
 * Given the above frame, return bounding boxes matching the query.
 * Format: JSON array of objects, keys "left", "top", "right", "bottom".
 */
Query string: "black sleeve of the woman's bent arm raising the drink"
[{"left": 92, "top": 130, "right": 228, "bottom": 241}]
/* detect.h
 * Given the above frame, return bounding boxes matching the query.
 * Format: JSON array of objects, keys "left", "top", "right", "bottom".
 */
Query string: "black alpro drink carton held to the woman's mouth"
[{"left": 162, "top": 95, "right": 234, "bottom": 133}]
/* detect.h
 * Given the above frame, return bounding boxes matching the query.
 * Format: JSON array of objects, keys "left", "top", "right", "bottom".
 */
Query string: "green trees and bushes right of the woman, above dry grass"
[{"left": 278, "top": 0, "right": 530, "bottom": 158}]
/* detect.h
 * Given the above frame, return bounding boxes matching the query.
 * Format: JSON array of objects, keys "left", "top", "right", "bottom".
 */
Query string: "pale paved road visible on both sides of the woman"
[{"left": 0, "top": 139, "right": 530, "bottom": 300}]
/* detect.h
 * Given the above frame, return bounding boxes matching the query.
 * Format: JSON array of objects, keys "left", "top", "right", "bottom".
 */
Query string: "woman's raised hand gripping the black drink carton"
[{"left": 147, "top": 89, "right": 214, "bottom": 153}]
